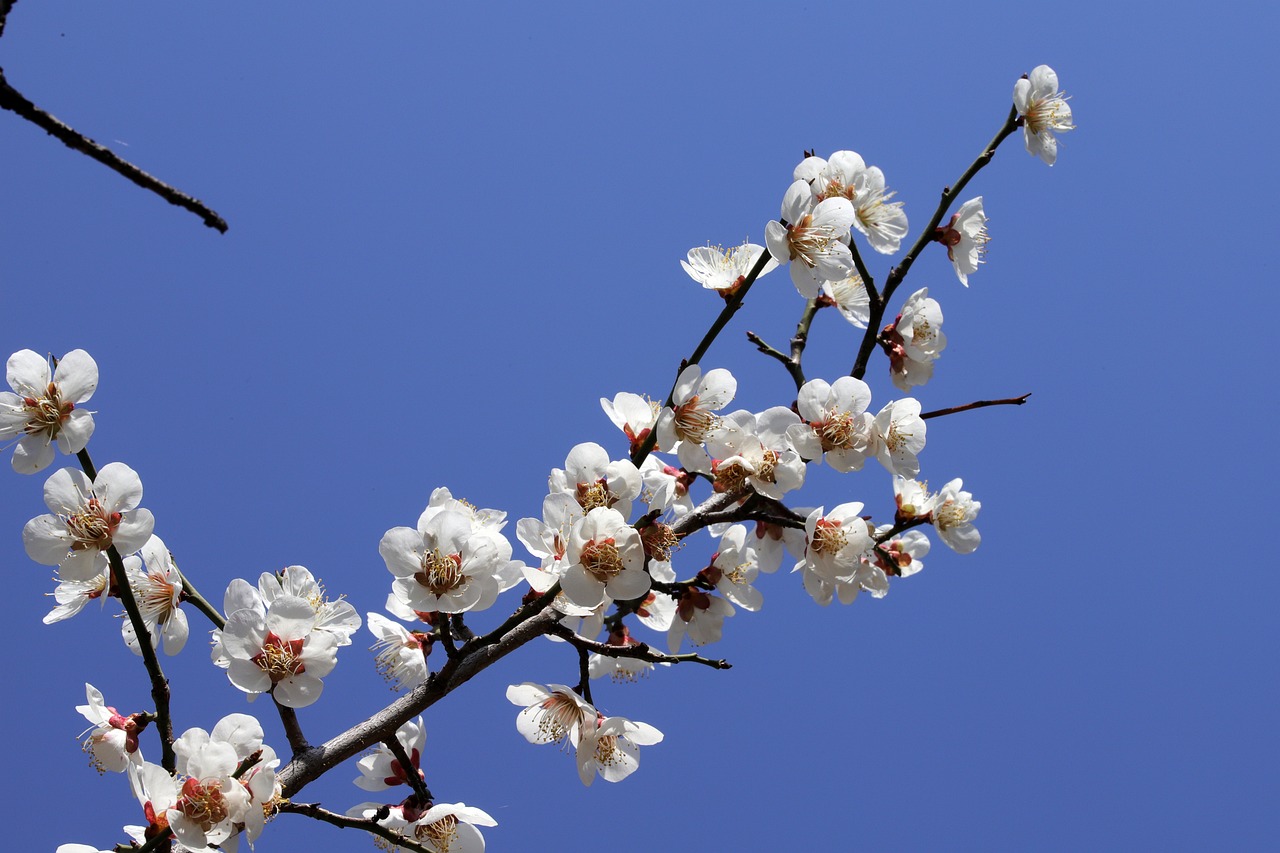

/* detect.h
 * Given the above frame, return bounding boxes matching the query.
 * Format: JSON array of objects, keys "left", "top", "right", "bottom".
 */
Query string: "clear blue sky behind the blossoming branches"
[{"left": 0, "top": 3, "right": 1280, "bottom": 853}]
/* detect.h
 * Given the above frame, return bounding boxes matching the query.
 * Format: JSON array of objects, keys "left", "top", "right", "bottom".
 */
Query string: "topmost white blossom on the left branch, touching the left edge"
[{"left": 0, "top": 350, "right": 97, "bottom": 474}]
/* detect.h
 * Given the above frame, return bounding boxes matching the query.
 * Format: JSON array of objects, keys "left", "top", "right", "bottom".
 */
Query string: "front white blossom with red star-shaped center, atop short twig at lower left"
[{"left": 221, "top": 596, "right": 338, "bottom": 708}]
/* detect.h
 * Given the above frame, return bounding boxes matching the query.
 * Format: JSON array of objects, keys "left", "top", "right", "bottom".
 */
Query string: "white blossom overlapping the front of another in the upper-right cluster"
[{"left": 764, "top": 179, "right": 856, "bottom": 300}]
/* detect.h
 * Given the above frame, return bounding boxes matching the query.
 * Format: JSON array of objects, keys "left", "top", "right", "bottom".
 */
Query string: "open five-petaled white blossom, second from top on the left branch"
[{"left": 22, "top": 462, "right": 155, "bottom": 580}]
